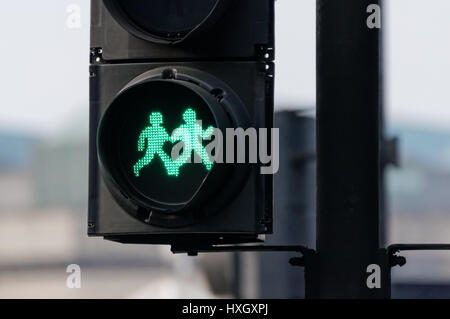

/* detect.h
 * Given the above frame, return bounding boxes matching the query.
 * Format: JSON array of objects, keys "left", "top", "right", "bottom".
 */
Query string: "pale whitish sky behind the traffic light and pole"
[{"left": 0, "top": 0, "right": 450, "bottom": 134}]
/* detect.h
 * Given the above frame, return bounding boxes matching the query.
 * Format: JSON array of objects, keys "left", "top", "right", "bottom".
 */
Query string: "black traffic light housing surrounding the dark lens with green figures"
[{"left": 88, "top": 0, "right": 274, "bottom": 245}]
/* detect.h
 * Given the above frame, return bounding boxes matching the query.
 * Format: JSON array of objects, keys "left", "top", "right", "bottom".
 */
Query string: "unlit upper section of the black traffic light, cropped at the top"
[{"left": 91, "top": 0, "right": 274, "bottom": 61}]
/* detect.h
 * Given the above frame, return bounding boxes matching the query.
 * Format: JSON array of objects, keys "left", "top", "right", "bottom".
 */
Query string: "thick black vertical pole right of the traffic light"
[{"left": 310, "top": 0, "right": 384, "bottom": 298}]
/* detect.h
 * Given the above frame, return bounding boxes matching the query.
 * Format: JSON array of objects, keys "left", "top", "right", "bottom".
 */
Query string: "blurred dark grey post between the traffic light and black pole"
[{"left": 244, "top": 107, "right": 316, "bottom": 298}]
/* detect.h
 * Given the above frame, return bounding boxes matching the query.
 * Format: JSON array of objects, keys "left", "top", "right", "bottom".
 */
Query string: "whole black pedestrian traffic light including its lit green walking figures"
[{"left": 88, "top": 0, "right": 274, "bottom": 245}]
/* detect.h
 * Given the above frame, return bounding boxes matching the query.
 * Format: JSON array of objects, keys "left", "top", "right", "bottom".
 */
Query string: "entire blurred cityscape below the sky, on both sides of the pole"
[{"left": 0, "top": 108, "right": 450, "bottom": 298}]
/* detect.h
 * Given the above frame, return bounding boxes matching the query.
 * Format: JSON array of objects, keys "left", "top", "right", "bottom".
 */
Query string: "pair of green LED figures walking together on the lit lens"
[{"left": 133, "top": 108, "right": 214, "bottom": 177}]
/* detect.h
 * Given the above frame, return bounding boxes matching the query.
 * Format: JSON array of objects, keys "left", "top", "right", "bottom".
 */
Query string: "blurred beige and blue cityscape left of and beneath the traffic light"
[{"left": 0, "top": 114, "right": 216, "bottom": 298}]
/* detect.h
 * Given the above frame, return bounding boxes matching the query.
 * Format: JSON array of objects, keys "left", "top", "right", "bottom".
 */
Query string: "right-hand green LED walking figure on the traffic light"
[{"left": 171, "top": 108, "right": 214, "bottom": 176}]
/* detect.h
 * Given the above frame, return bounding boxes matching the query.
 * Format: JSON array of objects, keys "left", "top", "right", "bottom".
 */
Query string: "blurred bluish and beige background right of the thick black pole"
[{"left": 387, "top": 125, "right": 450, "bottom": 298}]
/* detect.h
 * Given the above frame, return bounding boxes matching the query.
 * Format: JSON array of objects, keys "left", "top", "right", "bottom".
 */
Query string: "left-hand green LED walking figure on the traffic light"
[{"left": 134, "top": 112, "right": 178, "bottom": 177}]
